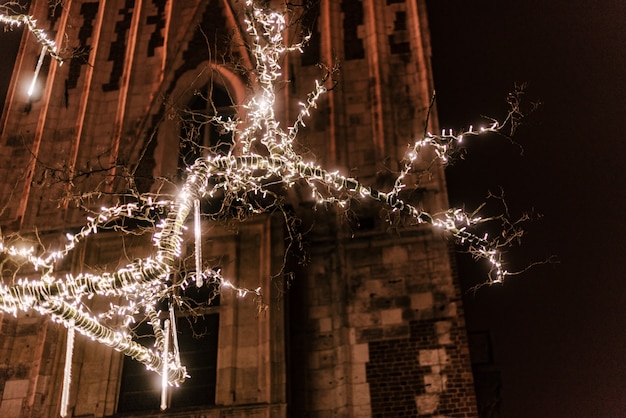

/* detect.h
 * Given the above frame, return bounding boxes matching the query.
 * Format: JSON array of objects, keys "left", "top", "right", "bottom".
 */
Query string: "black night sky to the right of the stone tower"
[{"left": 428, "top": 0, "right": 626, "bottom": 418}]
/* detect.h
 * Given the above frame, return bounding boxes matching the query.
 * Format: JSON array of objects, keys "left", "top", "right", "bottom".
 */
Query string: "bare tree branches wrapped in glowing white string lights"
[{"left": 0, "top": 0, "right": 508, "bottom": 408}]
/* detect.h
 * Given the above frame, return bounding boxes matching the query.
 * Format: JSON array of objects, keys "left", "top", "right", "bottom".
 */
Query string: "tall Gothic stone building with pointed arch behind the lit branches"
[{"left": 0, "top": 0, "right": 476, "bottom": 418}]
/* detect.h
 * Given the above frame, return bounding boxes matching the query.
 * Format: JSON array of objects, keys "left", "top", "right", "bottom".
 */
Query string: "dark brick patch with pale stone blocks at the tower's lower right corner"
[{"left": 367, "top": 320, "right": 476, "bottom": 417}]
